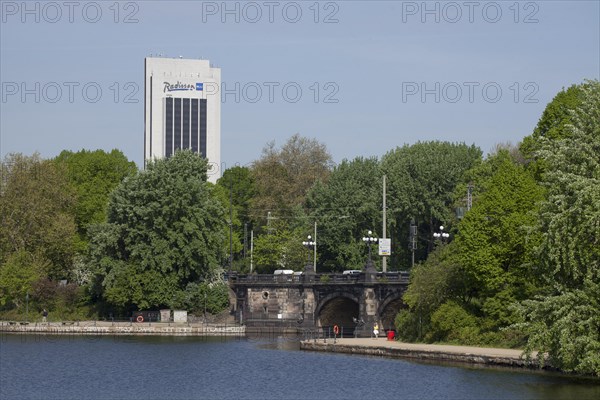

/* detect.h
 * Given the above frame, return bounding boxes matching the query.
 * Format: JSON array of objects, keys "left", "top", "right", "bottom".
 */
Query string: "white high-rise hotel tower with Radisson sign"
[{"left": 144, "top": 57, "right": 221, "bottom": 182}]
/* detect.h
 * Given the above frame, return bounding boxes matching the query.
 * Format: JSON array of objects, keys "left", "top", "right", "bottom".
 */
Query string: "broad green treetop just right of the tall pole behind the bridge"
[{"left": 379, "top": 141, "right": 481, "bottom": 267}]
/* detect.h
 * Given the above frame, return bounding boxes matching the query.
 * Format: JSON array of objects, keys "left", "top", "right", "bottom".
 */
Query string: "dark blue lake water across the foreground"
[{"left": 0, "top": 334, "right": 600, "bottom": 400}]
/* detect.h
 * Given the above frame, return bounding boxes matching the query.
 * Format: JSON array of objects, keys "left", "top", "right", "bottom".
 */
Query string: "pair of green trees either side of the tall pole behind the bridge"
[{"left": 306, "top": 142, "right": 481, "bottom": 270}]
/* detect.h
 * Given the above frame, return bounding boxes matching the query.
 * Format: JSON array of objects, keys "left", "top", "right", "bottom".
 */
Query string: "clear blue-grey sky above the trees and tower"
[{"left": 0, "top": 0, "right": 600, "bottom": 169}]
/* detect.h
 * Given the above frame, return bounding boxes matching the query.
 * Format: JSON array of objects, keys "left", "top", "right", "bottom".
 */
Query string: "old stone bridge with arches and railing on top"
[{"left": 229, "top": 269, "right": 408, "bottom": 336}]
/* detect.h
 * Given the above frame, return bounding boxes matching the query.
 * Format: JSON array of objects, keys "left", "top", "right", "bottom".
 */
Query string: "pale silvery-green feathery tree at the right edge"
[{"left": 522, "top": 81, "right": 600, "bottom": 376}]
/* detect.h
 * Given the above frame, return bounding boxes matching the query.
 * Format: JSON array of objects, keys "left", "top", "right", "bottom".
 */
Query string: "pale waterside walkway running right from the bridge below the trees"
[{"left": 300, "top": 338, "right": 538, "bottom": 368}]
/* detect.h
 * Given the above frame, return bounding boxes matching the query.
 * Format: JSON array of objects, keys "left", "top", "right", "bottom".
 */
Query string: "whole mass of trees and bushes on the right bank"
[{"left": 396, "top": 81, "right": 600, "bottom": 375}]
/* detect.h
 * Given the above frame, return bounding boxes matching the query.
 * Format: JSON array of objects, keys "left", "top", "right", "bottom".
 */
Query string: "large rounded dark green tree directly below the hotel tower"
[{"left": 90, "top": 151, "right": 227, "bottom": 309}]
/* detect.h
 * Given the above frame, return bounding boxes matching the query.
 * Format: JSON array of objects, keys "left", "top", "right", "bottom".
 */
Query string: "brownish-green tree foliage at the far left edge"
[{"left": 0, "top": 154, "right": 82, "bottom": 317}]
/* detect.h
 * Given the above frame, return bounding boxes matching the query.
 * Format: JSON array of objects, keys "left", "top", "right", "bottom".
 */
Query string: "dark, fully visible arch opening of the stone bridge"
[{"left": 315, "top": 293, "right": 360, "bottom": 329}]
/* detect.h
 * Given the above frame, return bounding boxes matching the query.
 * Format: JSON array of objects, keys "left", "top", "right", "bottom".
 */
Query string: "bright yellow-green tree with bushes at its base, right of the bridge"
[{"left": 403, "top": 149, "right": 544, "bottom": 345}]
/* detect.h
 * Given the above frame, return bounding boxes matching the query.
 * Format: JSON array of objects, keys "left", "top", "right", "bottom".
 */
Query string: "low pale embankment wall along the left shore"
[{"left": 0, "top": 321, "right": 246, "bottom": 337}]
